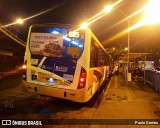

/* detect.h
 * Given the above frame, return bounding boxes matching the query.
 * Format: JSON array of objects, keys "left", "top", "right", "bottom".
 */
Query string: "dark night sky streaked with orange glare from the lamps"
[{"left": 0, "top": 0, "right": 160, "bottom": 52}]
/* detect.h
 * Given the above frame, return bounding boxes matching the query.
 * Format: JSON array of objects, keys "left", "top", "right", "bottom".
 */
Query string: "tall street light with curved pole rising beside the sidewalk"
[{"left": 104, "top": 6, "right": 130, "bottom": 82}]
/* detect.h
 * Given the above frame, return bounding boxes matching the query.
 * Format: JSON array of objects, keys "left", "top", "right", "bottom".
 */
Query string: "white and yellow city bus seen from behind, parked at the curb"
[{"left": 22, "top": 24, "right": 110, "bottom": 103}]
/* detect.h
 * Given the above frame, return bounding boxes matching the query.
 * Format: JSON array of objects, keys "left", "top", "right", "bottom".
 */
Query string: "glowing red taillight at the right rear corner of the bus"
[{"left": 77, "top": 68, "right": 86, "bottom": 89}]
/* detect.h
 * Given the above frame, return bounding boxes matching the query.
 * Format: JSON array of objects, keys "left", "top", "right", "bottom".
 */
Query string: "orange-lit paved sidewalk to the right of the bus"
[{"left": 94, "top": 75, "right": 160, "bottom": 119}]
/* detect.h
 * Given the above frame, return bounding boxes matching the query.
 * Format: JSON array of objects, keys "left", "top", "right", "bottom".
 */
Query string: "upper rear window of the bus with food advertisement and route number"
[{"left": 29, "top": 27, "right": 84, "bottom": 59}]
